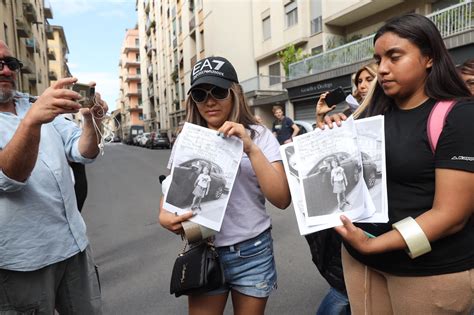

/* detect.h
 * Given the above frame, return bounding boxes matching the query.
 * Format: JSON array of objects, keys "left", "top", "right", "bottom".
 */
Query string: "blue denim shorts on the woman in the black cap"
[{"left": 206, "top": 229, "right": 277, "bottom": 298}]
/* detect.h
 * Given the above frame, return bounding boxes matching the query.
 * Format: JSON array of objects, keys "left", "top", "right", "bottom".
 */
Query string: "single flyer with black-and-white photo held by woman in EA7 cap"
[{"left": 163, "top": 123, "right": 243, "bottom": 231}]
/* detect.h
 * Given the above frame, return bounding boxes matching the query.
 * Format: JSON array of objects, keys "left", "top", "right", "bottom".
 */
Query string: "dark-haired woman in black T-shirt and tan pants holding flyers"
[{"left": 330, "top": 14, "right": 474, "bottom": 314}]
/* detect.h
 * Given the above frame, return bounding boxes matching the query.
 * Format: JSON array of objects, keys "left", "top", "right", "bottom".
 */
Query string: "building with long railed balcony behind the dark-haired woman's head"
[{"left": 283, "top": 0, "right": 474, "bottom": 121}]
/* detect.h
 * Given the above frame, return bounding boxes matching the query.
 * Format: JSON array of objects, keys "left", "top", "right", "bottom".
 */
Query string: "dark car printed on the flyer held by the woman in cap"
[{"left": 167, "top": 159, "right": 226, "bottom": 208}]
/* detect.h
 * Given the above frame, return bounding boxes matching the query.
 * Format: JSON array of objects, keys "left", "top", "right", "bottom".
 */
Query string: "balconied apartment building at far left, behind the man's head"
[{"left": 0, "top": 0, "right": 53, "bottom": 95}]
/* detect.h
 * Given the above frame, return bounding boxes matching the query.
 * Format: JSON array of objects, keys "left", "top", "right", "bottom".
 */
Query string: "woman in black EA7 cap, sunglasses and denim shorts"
[{"left": 159, "top": 57, "right": 291, "bottom": 315}]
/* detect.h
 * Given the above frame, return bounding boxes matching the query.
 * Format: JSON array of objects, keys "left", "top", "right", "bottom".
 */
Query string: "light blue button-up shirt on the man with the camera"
[{"left": 0, "top": 92, "right": 92, "bottom": 271}]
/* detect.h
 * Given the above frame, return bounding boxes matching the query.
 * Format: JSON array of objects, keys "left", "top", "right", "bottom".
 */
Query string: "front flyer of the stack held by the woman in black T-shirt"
[{"left": 294, "top": 117, "right": 364, "bottom": 225}]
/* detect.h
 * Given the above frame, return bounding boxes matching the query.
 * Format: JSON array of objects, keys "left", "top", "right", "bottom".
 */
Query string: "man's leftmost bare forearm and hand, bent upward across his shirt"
[{"left": 0, "top": 78, "right": 80, "bottom": 182}]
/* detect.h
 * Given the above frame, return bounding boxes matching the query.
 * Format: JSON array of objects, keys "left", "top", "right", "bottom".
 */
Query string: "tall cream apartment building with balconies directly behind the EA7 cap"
[{"left": 137, "top": 0, "right": 257, "bottom": 136}]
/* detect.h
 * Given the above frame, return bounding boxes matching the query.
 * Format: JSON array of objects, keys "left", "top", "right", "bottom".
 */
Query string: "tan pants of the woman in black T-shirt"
[{"left": 341, "top": 247, "right": 474, "bottom": 315}]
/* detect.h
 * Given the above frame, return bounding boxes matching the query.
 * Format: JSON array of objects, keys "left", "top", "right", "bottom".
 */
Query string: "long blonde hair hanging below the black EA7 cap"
[{"left": 186, "top": 83, "right": 259, "bottom": 139}]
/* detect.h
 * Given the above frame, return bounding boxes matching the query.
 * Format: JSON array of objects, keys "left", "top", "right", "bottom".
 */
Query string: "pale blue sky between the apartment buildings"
[{"left": 45, "top": 0, "right": 137, "bottom": 110}]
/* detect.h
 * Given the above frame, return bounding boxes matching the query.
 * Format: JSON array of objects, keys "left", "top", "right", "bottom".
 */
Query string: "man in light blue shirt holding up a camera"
[{"left": 0, "top": 41, "right": 107, "bottom": 314}]
